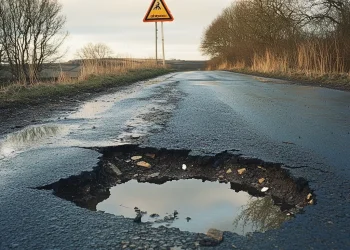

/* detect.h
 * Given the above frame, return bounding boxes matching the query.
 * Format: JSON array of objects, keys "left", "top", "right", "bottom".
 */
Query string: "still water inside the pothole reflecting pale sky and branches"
[{"left": 97, "top": 179, "right": 288, "bottom": 234}]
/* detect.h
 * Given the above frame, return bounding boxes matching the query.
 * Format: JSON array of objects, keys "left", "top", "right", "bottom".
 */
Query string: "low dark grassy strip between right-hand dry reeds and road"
[{"left": 228, "top": 70, "right": 350, "bottom": 91}]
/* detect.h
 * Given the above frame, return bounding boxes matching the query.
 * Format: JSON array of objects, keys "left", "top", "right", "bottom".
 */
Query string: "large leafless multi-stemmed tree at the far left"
[{"left": 0, "top": 0, "right": 67, "bottom": 84}]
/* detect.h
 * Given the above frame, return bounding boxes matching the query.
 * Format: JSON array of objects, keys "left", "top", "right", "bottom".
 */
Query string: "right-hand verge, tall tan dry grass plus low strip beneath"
[{"left": 208, "top": 42, "right": 350, "bottom": 91}]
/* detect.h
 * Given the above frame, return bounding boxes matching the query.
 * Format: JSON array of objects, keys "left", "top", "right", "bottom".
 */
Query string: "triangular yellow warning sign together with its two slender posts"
[{"left": 143, "top": 0, "right": 174, "bottom": 67}]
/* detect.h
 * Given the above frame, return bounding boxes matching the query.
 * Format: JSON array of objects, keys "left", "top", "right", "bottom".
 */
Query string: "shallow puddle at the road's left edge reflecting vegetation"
[{"left": 0, "top": 125, "right": 67, "bottom": 159}]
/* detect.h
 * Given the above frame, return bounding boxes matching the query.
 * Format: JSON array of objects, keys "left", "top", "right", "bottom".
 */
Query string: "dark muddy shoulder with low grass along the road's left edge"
[{"left": 0, "top": 69, "right": 171, "bottom": 135}]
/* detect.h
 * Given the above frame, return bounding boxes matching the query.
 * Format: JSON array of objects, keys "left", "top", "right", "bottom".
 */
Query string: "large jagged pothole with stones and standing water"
[{"left": 39, "top": 145, "right": 315, "bottom": 234}]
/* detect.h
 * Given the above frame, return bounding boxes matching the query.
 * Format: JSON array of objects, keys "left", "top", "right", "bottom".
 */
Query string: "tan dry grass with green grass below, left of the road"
[{"left": 0, "top": 59, "right": 171, "bottom": 106}]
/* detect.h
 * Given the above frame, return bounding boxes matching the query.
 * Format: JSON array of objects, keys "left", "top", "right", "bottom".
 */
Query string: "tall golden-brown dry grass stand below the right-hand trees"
[{"left": 208, "top": 41, "right": 350, "bottom": 84}]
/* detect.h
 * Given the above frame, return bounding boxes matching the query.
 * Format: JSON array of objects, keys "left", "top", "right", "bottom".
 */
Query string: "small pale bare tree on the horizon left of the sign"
[{"left": 76, "top": 43, "right": 113, "bottom": 60}]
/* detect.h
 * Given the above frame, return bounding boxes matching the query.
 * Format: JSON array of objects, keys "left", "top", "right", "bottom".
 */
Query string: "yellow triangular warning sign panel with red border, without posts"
[{"left": 143, "top": 0, "right": 174, "bottom": 22}]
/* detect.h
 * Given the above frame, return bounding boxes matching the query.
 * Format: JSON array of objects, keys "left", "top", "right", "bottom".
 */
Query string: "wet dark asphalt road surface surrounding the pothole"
[{"left": 0, "top": 71, "right": 350, "bottom": 249}]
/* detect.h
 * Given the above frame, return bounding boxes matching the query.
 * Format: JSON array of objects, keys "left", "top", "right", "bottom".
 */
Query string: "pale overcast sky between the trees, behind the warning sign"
[{"left": 59, "top": 0, "right": 233, "bottom": 60}]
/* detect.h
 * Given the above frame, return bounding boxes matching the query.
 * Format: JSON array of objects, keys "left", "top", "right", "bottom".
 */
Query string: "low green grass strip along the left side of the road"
[{"left": 0, "top": 68, "right": 172, "bottom": 107}]
